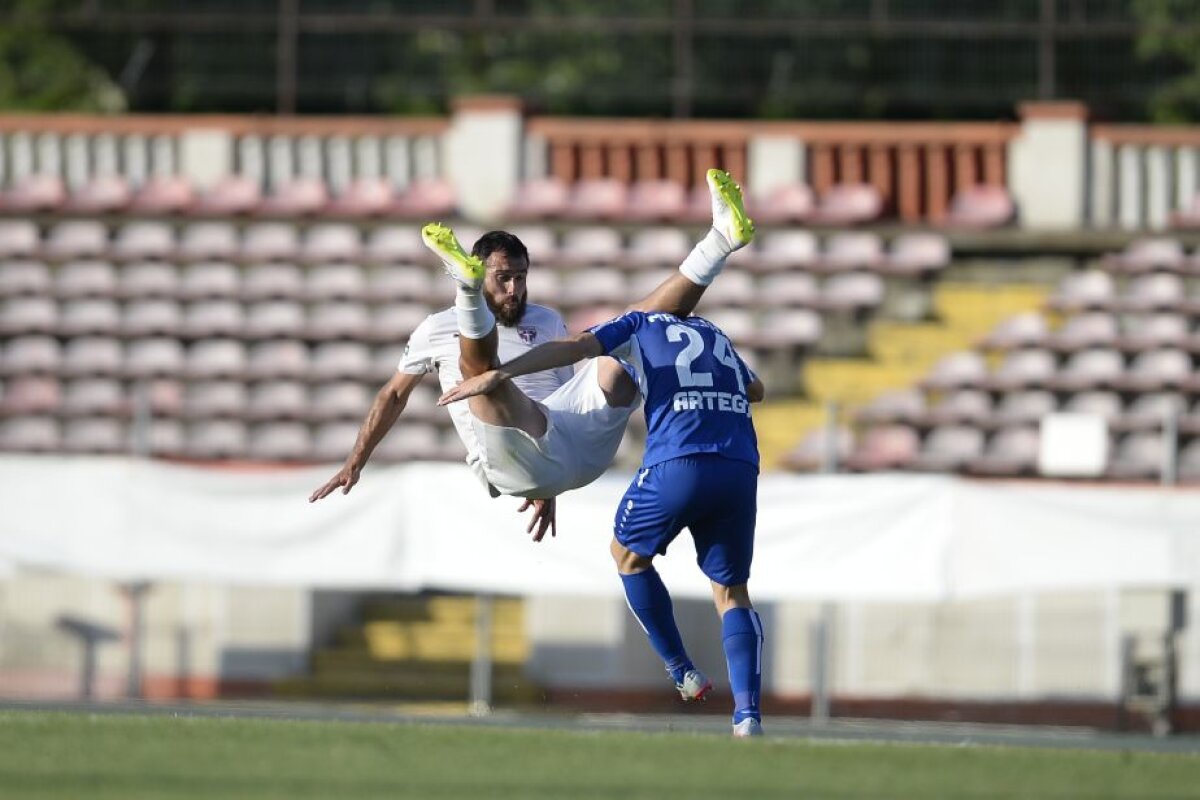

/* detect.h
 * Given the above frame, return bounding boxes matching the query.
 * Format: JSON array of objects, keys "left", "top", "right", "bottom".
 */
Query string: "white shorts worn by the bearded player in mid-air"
[{"left": 472, "top": 359, "right": 637, "bottom": 498}]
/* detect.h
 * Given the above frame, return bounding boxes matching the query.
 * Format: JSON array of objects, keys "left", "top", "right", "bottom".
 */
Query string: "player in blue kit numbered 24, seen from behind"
[{"left": 439, "top": 304, "right": 763, "bottom": 736}]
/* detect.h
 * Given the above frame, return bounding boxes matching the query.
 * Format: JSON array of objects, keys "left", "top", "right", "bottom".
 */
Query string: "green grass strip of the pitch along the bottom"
[{"left": 0, "top": 711, "right": 1200, "bottom": 800}]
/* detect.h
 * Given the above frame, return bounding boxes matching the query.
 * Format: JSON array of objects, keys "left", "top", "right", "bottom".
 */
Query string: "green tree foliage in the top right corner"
[{"left": 1133, "top": 0, "right": 1200, "bottom": 122}]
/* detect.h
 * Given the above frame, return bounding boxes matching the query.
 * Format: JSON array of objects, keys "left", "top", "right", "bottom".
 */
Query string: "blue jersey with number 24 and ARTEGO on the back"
[{"left": 589, "top": 311, "right": 758, "bottom": 467}]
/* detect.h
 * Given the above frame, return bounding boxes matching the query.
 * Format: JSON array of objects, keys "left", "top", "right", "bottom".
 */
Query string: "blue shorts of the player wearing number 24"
[{"left": 613, "top": 453, "right": 758, "bottom": 587}]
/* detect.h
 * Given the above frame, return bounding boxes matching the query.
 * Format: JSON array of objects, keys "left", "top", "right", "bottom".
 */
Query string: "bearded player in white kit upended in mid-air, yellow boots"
[{"left": 310, "top": 169, "right": 754, "bottom": 541}]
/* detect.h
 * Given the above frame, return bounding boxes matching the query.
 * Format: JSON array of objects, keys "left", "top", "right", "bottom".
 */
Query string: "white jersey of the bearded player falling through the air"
[{"left": 398, "top": 303, "right": 574, "bottom": 491}]
